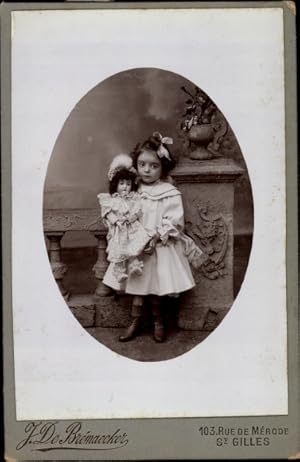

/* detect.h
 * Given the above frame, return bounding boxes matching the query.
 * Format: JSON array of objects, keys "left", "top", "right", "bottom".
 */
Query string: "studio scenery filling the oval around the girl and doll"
[{"left": 43, "top": 68, "right": 253, "bottom": 361}]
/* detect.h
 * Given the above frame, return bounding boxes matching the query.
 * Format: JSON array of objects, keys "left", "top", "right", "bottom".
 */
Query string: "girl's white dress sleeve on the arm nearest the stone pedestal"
[{"left": 157, "top": 194, "right": 184, "bottom": 245}]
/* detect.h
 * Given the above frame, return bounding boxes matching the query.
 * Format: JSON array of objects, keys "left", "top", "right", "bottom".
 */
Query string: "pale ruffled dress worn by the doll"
[{"left": 97, "top": 192, "right": 151, "bottom": 263}]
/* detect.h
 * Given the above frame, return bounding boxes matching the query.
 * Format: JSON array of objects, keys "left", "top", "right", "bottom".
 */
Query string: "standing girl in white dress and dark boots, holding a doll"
[{"left": 120, "top": 132, "right": 205, "bottom": 342}]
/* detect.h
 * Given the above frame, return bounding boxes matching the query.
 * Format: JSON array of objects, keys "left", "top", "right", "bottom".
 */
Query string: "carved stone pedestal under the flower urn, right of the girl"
[{"left": 172, "top": 159, "right": 243, "bottom": 330}]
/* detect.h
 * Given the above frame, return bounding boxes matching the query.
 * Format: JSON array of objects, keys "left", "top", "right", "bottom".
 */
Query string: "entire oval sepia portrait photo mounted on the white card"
[{"left": 43, "top": 68, "right": 253, "bottom": 361}]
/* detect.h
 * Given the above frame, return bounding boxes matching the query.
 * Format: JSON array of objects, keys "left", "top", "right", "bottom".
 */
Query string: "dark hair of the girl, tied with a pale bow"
[{"left": 131, "top": 135, "right": 176, "bottom": 179}]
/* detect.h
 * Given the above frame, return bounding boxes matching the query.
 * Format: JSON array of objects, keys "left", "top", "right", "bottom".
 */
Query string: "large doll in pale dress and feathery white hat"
[{"left": 97, "top": 154, "right": 151, "bottom": 284}]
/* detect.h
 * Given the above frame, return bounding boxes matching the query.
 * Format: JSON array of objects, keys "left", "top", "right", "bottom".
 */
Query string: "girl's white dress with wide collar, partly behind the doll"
[{"left": 103, "top": 180, "right": 203, "bottom": 296}]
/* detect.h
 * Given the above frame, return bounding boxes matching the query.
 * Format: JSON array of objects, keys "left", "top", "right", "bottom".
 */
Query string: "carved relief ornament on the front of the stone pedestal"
[{"left": 186, "top": 206, "right": 228, "bottom": 279}]
